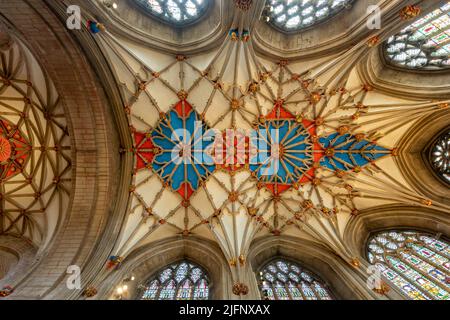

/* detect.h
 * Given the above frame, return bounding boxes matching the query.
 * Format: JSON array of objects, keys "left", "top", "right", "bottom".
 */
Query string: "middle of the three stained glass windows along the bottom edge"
[{"left": 259, "top": 259, "right": 333, "bottom": 300}]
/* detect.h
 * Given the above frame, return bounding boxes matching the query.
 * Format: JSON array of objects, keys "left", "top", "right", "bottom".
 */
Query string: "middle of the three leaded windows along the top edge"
[{"left": 266, "top": 0, "right": 353, "bottom": 32}]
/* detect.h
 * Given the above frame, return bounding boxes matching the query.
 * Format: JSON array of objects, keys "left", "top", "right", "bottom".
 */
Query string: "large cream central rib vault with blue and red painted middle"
[{"left": 99, "top": 2, "right": 449, "bottom": 284}]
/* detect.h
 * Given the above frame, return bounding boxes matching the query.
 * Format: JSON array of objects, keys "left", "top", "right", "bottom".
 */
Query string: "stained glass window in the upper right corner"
[{"left": 385, "top": 2, "right": 450, "bottom": 70}]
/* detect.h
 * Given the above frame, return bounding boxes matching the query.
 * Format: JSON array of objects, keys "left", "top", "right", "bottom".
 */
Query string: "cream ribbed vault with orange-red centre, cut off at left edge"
[{"left": 0, "top": 41, "right": 71, "bottom": 246}]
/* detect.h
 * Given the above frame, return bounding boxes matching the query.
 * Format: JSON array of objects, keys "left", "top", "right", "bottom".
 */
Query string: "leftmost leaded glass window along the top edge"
[{"left": 136, "top": 0, "right": 210, "bottom": 25}]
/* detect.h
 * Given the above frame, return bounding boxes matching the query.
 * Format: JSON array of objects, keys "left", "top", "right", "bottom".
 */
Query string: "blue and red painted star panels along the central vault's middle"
[{"left": 134, "top": 100, "right": 391, "bottom": 200}]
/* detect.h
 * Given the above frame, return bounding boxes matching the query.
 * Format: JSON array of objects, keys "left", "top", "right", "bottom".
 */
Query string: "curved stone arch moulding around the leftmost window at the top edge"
[{"left": 78, "top": 0, "right": 234, "bottom": 54}]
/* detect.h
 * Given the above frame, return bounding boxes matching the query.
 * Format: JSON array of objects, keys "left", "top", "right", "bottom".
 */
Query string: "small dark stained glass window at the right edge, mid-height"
[{"left": 430, "top": 131, "right": 450, "bottom": 183}]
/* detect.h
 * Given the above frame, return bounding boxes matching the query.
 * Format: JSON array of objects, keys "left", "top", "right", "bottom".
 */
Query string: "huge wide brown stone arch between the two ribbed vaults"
[{"left": 0, "top": 1, "right": 125, "bottom": 299}]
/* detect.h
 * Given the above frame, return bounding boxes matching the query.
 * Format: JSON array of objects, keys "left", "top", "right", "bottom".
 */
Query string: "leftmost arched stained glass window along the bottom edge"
[{"left": 140, "top": 261, "right": 209, "bottom": 300}]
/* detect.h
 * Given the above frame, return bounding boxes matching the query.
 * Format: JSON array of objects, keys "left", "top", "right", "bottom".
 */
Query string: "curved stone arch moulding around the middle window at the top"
[{"left": 254, "top": 0, "right": 442, "bottom": 60}]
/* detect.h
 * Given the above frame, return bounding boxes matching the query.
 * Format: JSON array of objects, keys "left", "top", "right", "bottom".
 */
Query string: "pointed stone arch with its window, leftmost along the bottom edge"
[{"left": 97, "top": 236, "right": 233, "bottom": 300}]
